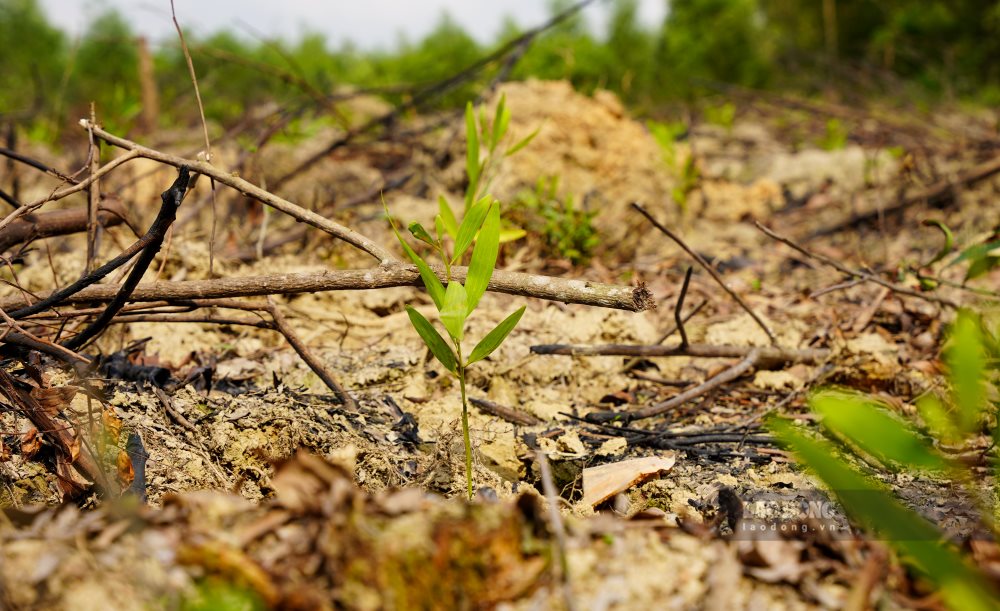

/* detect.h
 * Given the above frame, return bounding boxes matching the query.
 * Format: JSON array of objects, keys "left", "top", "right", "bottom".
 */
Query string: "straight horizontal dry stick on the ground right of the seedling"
[{"left": 531, "top": 344, "right": 830, "bottom": 369}]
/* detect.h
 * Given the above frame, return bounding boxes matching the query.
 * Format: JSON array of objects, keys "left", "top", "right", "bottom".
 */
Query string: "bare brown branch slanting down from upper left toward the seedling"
[{"left": 80, "top": 119, "right": 396, "bottom": 264}]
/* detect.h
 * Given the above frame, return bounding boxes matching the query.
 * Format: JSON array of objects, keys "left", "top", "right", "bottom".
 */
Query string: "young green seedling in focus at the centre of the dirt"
[{"left": 386, "top": 196, "right": 524, "bottom": 499}]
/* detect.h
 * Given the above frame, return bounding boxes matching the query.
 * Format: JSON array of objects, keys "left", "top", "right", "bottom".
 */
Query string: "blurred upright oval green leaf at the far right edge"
[{"left": 945, "top": 311, "right": 986, "bottom": 433}]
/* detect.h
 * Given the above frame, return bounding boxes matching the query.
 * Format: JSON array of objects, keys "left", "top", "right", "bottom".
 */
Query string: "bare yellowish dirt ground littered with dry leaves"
[{"left": 0, "top": 83, "right": 1000, "bottom": 609}]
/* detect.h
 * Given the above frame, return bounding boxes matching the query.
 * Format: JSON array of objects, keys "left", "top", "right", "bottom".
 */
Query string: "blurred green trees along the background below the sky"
[{"left": 0, "top": 0, "right": 1000, "bottom": 142}]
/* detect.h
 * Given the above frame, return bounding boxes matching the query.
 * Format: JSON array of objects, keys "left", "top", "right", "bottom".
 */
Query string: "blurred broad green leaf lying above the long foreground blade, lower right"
[{"left": 809, "top": 391, "right": 950, "bottom": 471}]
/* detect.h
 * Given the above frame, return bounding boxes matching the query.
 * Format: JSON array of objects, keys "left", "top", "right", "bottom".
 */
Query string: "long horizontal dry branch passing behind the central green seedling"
[{"left": 0, "top": 264, "right": 656, "bottom": 312}]
